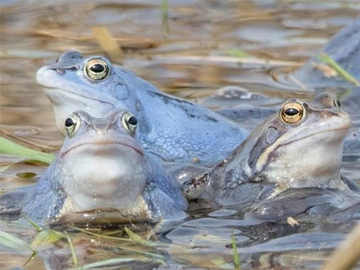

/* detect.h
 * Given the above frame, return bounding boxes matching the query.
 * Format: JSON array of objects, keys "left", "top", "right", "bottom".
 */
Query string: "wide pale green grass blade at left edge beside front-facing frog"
[{"left": 0, "top": 136, "right": 55, "bottom": 164}]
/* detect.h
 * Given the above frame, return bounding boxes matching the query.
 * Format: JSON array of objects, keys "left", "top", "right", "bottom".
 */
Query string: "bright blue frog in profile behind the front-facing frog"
[{"left": 37, "top": 51, "right": 248, "bottom": 166}]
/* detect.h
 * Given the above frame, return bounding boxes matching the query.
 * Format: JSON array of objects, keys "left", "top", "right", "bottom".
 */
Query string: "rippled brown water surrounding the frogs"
[{"left": 0, "top": 0, "right": 360, "bottom": 269}]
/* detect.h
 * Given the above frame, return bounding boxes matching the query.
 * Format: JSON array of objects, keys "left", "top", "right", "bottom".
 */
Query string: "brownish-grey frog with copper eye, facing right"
[{"left": 184, "top": 93, "right": 351, "bottom": 205}]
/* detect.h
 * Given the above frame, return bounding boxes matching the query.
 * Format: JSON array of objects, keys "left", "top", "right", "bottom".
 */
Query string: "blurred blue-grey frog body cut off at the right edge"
[{"left": 293, "top": 17, "right": 360, "bottom": 89}]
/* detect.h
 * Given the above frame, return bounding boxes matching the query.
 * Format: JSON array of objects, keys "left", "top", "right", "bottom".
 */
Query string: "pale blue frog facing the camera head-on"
[{"left": 0, "top": 111, "right": 187, "bottom": 226}]
